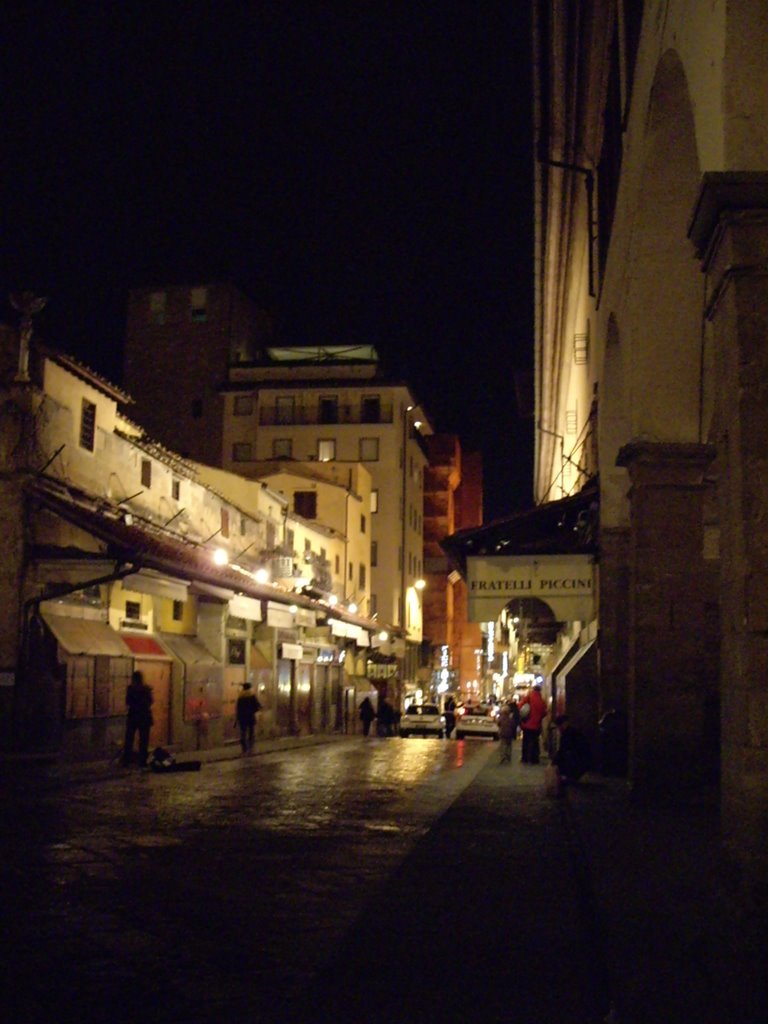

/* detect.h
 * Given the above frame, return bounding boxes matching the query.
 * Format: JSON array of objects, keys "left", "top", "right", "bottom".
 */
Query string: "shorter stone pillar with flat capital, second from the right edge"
[{"left": 617, "top": 441, "right": 718, "bottom": 795}]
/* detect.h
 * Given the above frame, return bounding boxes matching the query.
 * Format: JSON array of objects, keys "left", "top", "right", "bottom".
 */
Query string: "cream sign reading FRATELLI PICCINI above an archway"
[{"left": 467, "top": 555, "right": 595, "bottom": 623}]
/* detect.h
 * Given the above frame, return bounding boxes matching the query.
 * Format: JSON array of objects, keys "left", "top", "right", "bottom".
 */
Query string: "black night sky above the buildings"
[{"left": 0, "top": 0, "right": 532, "bottom": 519}]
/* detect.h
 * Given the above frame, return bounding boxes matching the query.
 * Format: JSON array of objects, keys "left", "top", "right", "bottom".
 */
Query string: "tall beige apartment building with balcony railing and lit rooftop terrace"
[{"left": 222, "top": 346, "right": 432, "bottom": 695}]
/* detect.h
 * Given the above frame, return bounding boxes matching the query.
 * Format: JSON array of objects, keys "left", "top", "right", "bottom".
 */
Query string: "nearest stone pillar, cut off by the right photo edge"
[{"left": 689, "top": 172, "right": 768, "bottom": 909}]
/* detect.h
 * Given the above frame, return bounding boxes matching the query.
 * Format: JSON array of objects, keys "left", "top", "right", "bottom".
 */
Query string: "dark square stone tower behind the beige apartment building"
[{"left": 123, "top": 284, "right": 271, "bottom": 466}]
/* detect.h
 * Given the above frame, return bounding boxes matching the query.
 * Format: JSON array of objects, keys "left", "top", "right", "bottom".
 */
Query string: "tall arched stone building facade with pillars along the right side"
[{"left": 532, "top": 0, "right": 768, "bottom": 902}]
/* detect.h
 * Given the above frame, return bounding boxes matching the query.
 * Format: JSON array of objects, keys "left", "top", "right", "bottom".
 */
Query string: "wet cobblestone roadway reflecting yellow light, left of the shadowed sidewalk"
[{"left": 2, "top": 739, "right": 488, "bottom": 1022}]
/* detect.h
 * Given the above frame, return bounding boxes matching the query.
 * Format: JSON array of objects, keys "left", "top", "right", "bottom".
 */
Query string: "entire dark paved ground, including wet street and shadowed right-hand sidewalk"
[{"left": 0, "top": 738, "right": 768, "bottom": 1024}]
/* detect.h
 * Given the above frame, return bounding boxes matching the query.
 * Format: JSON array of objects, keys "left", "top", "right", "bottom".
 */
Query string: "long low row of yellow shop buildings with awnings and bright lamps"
[{"left": 0, "top": 323, "right": 381, "bottom": 757}]
